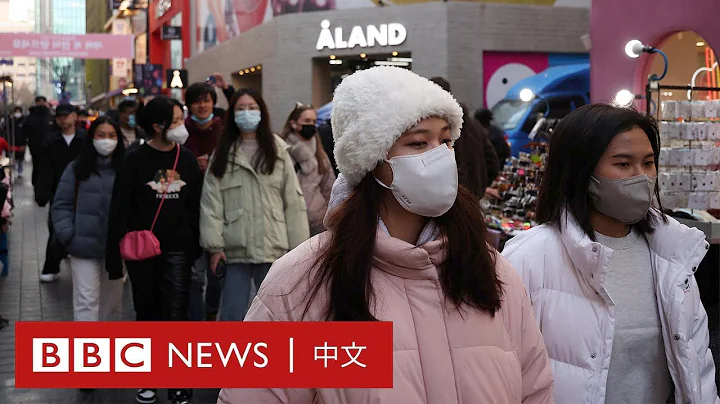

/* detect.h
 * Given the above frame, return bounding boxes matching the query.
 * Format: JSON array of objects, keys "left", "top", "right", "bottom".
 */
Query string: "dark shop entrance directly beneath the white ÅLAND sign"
[{"left": 313, "top": 52, "right": 412, "bottom": 110}]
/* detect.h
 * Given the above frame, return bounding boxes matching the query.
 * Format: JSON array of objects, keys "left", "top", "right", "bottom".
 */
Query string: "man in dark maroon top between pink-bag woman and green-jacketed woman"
[{"left": 183, "top": 82, "right": 222, "bottom": 321}]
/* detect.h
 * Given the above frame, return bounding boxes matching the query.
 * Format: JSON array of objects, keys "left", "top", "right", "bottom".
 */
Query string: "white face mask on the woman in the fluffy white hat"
[{"left": 375, "top": 144, "right": 458, "bottom": 217}]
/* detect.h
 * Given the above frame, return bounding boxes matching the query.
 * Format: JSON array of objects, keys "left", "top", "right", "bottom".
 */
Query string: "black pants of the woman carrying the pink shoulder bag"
[{"left": 126, "top": 252, "right": 193, "bottom": 321}]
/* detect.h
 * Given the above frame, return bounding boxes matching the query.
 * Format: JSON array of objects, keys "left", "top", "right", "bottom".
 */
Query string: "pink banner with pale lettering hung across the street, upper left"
[{"left": 0, "top": 33, "right": 134, "bottom": 59}]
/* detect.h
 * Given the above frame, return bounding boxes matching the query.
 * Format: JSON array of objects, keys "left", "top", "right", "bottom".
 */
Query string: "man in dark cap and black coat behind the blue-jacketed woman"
[{"left": 35, "top": 104, "right": 85, "bottom": 282}]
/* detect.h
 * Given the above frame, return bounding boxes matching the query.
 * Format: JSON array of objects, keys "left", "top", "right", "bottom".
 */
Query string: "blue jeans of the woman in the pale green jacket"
[{"left": 218, "top": 263, "right": 272, "bottom": 321}]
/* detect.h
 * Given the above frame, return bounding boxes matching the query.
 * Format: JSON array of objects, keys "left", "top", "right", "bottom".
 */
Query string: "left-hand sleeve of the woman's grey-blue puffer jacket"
[{"left": 50, "top": 164, "right": 75, "bottom": 246}]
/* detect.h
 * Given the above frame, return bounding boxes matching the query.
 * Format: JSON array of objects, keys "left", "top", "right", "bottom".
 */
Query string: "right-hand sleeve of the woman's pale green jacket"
[{"left": 276, "top": 141, "right": 310, "bottom": 250}]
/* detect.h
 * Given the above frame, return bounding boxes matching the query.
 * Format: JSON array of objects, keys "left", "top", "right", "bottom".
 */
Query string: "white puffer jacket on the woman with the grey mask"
[{"left": 502, "top": 211, "right": 720, "bottom": 404}]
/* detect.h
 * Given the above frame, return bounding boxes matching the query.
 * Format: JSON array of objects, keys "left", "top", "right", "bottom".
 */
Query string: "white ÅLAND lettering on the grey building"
[{"left": 315, "top": 20, "right": 407, "bottom": 50}]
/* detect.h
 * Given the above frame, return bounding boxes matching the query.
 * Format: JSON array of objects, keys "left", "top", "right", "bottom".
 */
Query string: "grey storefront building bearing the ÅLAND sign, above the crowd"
[{"left": 186, "top": 2, "right": 589, "bottom": 128}]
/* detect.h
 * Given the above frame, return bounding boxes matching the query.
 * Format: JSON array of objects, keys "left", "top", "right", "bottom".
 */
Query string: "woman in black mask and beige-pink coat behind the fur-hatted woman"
[{"left": 282, "top": 103, "right": 335, "bottom": 236}]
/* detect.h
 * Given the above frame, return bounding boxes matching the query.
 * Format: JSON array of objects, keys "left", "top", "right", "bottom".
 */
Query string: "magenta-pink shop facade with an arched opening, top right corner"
[{"left": 590, "top": 0, "right": 720, "bottom": 107}]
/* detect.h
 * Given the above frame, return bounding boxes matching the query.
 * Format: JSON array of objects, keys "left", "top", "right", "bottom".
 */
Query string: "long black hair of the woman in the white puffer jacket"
[{"left": 537, "top": 104, "right": 667, "bottom": 240}]
